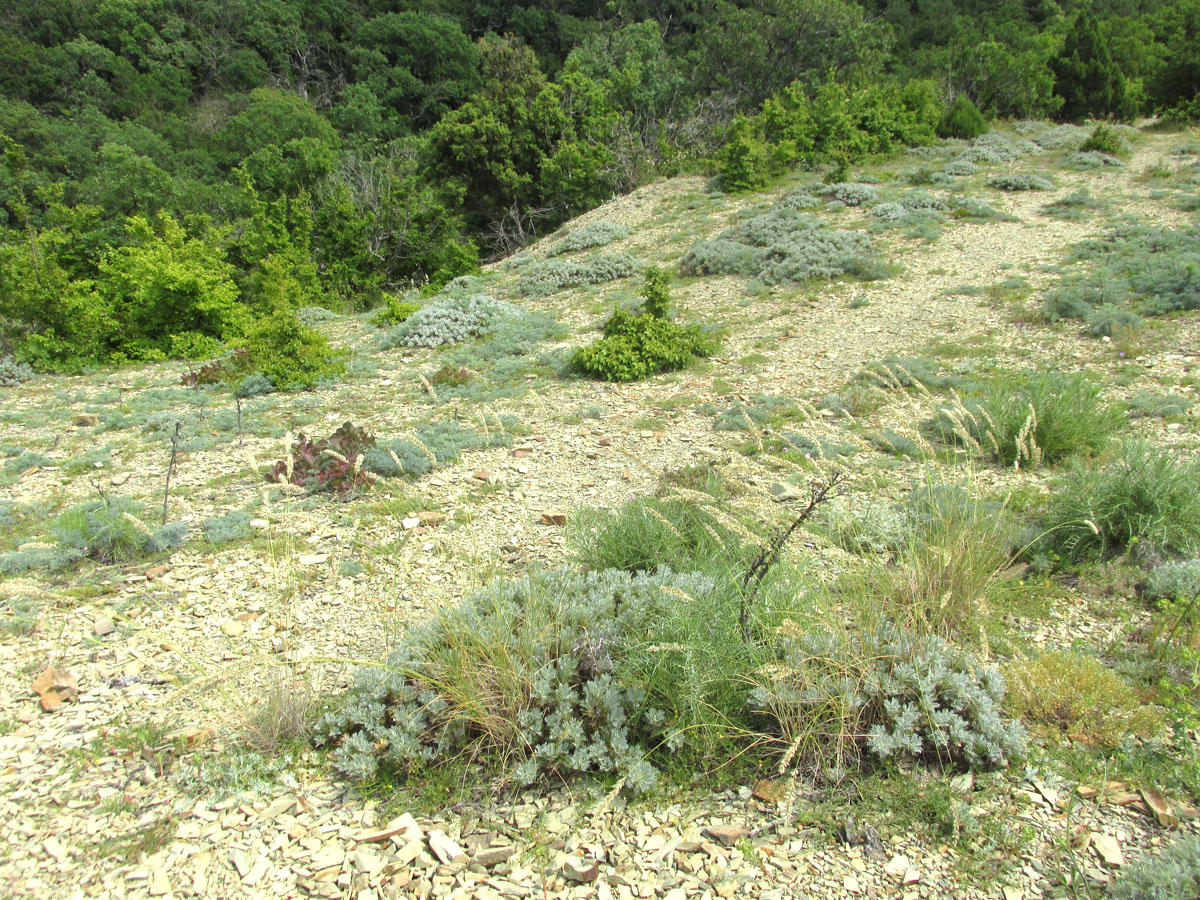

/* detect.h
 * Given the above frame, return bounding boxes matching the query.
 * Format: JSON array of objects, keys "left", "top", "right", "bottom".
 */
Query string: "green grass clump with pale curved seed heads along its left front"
[{"left": 926, "top": 372, "right": 1124, "bottom": 468}]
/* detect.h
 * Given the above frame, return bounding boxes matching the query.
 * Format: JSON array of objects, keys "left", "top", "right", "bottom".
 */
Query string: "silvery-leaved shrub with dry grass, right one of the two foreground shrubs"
[{"left": 751, "top": 620, "right": 1026, "bottom": 774}]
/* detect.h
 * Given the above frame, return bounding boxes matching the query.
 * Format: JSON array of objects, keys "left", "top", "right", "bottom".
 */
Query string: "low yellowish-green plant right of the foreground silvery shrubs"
[{"left": 1003, "top": 650, "right": 1163, "bottom": 746}]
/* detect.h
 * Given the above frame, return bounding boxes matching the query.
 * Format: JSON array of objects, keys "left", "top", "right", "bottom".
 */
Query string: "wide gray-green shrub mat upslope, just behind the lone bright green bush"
[{"left": 679, "top": 208, "right": 887, "bottom": 284}]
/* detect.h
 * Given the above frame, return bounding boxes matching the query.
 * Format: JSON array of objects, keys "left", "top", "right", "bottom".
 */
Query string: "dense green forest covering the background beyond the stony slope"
[{"left": 0, "top": 0, "right": 1200, "bottom": 371}]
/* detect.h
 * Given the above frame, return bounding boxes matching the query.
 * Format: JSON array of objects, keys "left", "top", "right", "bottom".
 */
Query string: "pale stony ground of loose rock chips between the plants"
[{"left": 0, "top": 127, "right": 1200, "bottom": 900}]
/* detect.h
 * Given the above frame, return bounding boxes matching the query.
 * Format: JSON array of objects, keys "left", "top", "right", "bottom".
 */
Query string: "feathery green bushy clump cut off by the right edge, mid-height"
[{"left": 1042, "top": 440, "right": 1200, "bottom": 562}]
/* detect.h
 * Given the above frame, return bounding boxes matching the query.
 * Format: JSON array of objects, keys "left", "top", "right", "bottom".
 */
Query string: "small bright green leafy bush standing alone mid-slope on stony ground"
[{"left": 571, "top": 307, "right": 716, "bottom": 382}]
